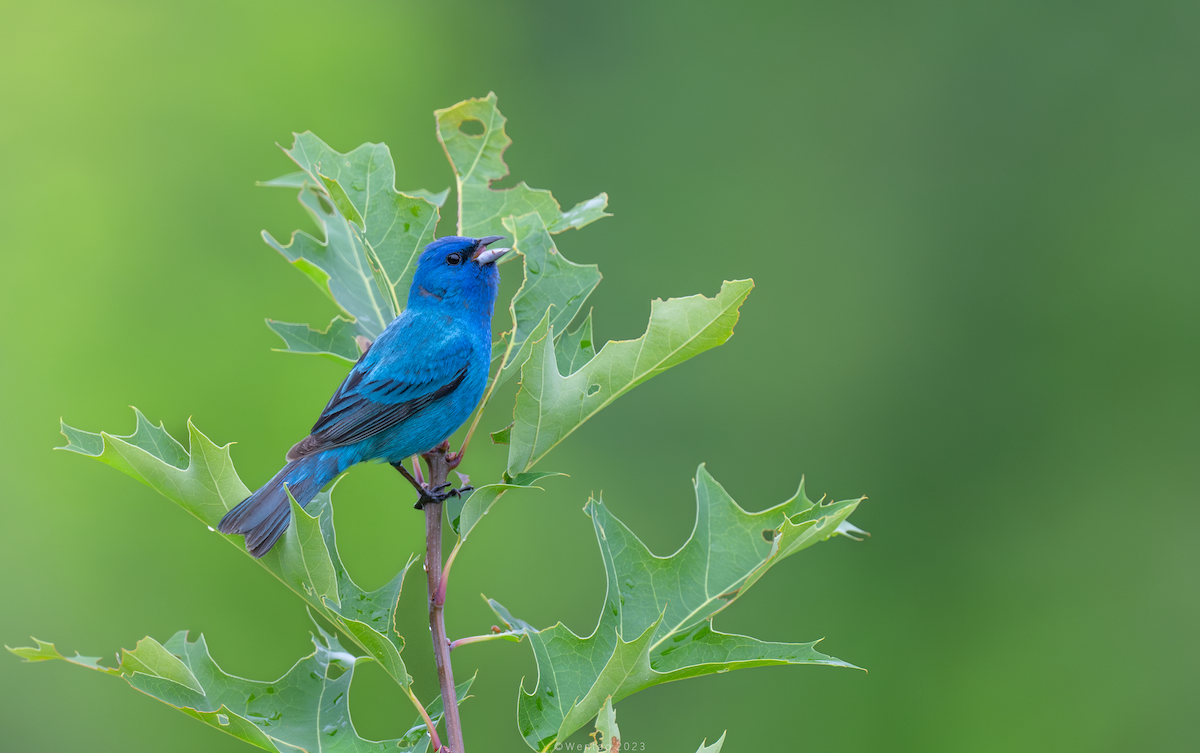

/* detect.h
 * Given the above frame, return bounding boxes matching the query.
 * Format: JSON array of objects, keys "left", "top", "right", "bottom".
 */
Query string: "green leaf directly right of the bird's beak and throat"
[{"left": 492, "top": 213, "right": 600, "bottom": 385}]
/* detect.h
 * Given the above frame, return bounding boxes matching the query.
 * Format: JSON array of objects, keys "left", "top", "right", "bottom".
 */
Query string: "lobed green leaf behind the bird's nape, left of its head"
[{"left": 263, "top": 132, "right": 445, "bottom": 345}]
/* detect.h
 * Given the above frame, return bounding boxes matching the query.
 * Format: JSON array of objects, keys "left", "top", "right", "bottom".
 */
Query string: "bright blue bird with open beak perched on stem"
[{"left": 218, "top": 235, "right": 509, "bottom": 558}]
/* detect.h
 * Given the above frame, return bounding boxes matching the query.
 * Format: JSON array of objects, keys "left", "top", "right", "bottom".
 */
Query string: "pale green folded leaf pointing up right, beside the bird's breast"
[{"left": 508, "top": 279, "right": 754, "bottom": 476}]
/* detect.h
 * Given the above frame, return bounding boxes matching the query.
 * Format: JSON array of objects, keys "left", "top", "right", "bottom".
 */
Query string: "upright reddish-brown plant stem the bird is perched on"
[{"left": 425, "top": 447, "right": 464, "bottom": 753}]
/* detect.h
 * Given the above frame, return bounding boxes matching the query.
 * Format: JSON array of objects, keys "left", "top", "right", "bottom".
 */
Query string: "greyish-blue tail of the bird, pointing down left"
[{"left": 217, "top": 453, "right": 338, "bottom": 558}]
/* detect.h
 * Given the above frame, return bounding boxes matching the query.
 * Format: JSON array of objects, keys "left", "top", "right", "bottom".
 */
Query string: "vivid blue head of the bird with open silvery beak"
[{"left": 408, "top": 235, "right": 509, "bottom": 318}]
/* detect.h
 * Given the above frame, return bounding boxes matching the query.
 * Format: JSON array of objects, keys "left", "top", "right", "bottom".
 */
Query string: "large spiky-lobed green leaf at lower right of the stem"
[{"left": 488, "top": 465, "right": 862, "bottom": 751}]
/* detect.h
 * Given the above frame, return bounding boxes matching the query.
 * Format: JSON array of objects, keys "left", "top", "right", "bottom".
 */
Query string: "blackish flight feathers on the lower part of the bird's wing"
[{"left": 288, "top": 366, "right": 467, "bottom": 460}]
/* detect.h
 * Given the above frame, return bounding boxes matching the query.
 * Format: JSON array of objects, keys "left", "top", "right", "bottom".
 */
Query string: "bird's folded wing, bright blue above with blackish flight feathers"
[{"left": 288, "top": 318, "right": 469, "bottom": 460}]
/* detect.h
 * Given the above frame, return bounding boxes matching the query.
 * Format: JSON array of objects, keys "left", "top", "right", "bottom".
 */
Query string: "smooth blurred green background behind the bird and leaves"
[{"left": 0, "top": 0, "right": 1200, "bottom": 753}]
